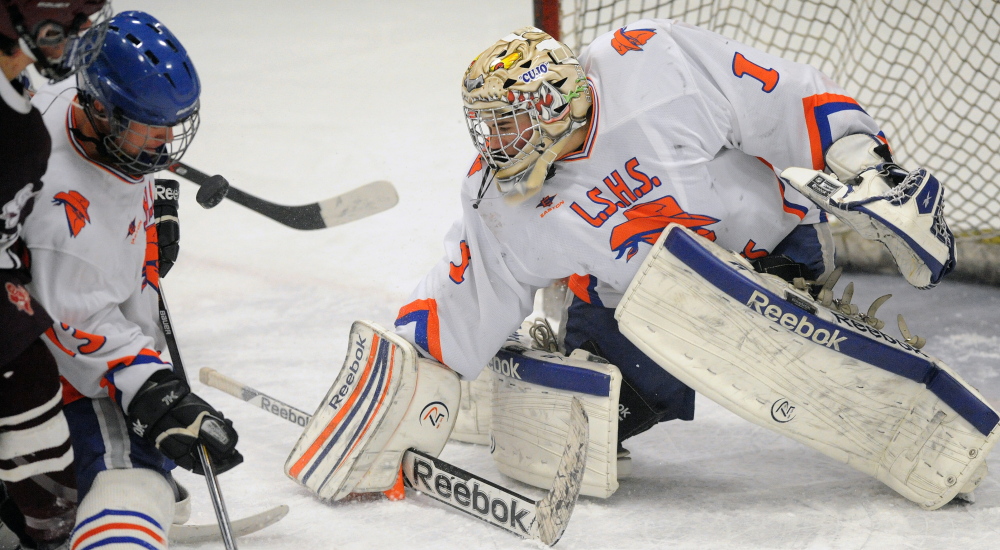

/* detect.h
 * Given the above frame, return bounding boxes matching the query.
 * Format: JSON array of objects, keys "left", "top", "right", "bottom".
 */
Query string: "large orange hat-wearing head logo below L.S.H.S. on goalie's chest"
[{"left": 611, "top": 195, "right": 719, "bottom": 261}]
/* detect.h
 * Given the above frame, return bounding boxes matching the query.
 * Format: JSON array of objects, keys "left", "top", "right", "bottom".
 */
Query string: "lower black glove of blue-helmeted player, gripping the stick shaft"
[{"left": 128, "top": 370, "right": 243, "bottom": 475}]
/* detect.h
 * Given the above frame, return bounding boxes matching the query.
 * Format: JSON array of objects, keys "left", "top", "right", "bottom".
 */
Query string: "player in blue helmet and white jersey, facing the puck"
[{"left": 25, "top": 11, "right": 242, "bottom": 549}]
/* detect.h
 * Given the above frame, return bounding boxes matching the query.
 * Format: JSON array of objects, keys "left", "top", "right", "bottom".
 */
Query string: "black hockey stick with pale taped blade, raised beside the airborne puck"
[{"left": 167, "top": 162, "right": 399, "bottom": 230}]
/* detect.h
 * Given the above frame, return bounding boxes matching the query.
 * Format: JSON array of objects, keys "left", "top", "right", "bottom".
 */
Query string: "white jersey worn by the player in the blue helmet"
[{"left": 24, "top": 79, "right": 170, "bottom": 410}]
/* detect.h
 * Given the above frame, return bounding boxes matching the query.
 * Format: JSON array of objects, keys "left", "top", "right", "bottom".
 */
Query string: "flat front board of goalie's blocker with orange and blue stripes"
[{"left": 285, "top": 321, "right": 417, "bottom": 500}]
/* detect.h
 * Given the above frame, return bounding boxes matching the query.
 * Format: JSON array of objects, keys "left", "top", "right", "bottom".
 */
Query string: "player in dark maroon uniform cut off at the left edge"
[{"left": 0, "top": 0, "right": 110, "bottom": 548}]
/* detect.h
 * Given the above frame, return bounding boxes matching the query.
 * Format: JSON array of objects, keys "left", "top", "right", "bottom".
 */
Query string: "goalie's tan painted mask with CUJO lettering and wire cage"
[{"left": 462, "top": 27, "right": 591, "bottom": 203}]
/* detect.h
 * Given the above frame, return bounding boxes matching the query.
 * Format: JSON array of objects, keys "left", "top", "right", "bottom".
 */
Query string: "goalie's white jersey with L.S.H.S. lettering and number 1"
[{"left": 396, "top": 20, "right": 884, "bottom": 378}]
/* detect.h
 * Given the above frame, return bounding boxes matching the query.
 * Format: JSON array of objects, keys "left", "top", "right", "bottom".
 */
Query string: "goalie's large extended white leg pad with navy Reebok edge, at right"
[{"left": 615, "top": 225, "right": 1000, "bottom": 509}]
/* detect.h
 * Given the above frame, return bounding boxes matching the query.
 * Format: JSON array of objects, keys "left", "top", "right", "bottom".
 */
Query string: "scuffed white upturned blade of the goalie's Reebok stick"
[{"left": 535, "top": 397, "right": 590, "bottom": 546}]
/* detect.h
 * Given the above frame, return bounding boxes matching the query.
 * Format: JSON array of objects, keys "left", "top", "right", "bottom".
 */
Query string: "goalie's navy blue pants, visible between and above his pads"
[{"left": 566, "top": 223, "right": 833, "bottom": 442}]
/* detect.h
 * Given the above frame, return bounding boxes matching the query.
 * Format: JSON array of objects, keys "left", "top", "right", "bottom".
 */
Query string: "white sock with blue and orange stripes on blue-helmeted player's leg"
[{"left": 71, "top": 468, "right": 174, "bottom": 550}]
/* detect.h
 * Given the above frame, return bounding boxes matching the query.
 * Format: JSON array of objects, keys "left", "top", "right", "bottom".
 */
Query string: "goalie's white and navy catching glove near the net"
[{"left": 781, "top": 164, "right": 955, "bottom": 288}]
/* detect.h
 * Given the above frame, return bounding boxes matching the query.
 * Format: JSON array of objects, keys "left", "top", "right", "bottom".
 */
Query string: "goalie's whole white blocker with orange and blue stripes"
[{"left": 285, "top": 321, "right": 460, "bottom": 500}]
